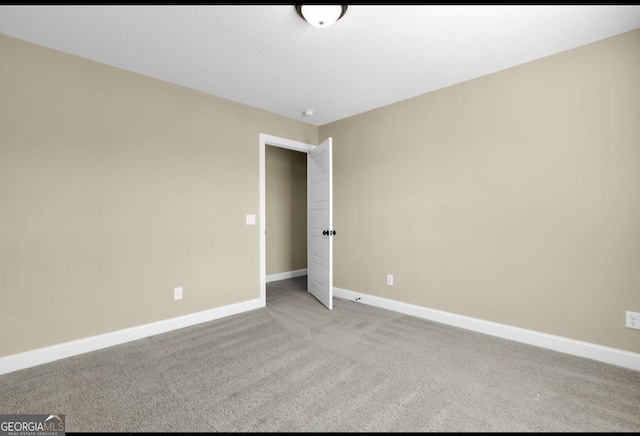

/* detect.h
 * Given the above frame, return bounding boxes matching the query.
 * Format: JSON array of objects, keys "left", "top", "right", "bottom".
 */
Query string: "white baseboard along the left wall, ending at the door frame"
[{"left": 0, "top": 298, "right": 264, "bottom": 374}]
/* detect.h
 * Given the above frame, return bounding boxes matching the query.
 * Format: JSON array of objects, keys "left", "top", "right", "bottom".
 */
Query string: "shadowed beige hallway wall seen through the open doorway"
[{"left": 265, "top": 146, "right": 307, "bottom": 274}]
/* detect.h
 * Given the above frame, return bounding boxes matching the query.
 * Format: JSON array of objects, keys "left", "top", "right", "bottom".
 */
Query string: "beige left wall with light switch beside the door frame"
[{"left": 0, "top": 36, "right": 318, "bottom": 357}]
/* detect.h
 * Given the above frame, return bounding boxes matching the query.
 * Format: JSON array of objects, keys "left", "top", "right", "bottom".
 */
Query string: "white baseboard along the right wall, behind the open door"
[{"left": 333, "top": 287, "right": 640, "bottom": 371}]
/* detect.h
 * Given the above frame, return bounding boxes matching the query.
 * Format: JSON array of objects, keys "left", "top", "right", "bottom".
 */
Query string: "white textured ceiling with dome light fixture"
[{"left": 0, "top": 5, "right": 640, "bottom": 126}]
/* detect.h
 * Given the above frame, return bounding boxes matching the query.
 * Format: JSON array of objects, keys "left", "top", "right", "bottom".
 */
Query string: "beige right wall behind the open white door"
[{"left": 319, "top": 30, "right": 640, "bottom": 352}]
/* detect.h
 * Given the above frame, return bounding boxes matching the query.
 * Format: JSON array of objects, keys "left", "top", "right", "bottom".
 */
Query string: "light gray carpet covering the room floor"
[{"left": 0, "top": 277, "right": 640, "bottom": 432}]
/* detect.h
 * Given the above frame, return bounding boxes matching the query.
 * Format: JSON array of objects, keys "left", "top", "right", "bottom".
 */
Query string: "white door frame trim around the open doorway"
[{"left": 258, "top": 133, "right": 315, "bottom": 307}]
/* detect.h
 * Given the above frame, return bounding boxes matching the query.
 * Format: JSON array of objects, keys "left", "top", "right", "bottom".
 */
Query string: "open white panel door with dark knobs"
[{"left": 307, "top": 138, "right": 335, "bottom": 310}]
